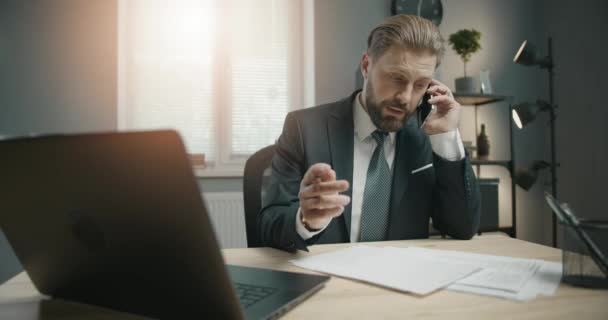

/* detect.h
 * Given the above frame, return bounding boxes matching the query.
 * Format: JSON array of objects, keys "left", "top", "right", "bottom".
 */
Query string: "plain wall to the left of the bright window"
[{"left": 0, "top": 0, "right": 117, "bottom": 282}]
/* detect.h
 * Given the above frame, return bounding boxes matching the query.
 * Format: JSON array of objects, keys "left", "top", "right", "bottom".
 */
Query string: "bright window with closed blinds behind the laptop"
[{"left": 118, "top": 0, "right": 302, "bottom": 175}]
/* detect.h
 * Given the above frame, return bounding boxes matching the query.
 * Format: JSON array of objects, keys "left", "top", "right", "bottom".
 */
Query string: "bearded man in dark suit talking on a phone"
[{"left": 258, "top": 15, "right": 480, "bottom": 251}]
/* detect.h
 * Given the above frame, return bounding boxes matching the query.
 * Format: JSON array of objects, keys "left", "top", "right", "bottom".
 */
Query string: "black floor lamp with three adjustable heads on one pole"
[{"left": 512, "top": 37, "right": 558, "bottom": 247}]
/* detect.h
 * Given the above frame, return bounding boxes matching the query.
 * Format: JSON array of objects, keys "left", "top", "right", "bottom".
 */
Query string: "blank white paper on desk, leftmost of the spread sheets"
[{"left": 290, "top": 246, "right": 480, "bottom": 295}]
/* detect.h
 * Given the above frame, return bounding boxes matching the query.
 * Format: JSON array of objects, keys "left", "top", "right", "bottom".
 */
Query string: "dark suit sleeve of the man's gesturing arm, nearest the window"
[{"left": 258, "top": 113, "right": 317, "bottom": 252}]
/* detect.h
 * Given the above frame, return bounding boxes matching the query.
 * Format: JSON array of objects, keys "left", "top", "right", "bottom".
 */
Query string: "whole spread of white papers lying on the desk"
[{"left": 291, "top": 246, "right": 561, "bottom": 301}]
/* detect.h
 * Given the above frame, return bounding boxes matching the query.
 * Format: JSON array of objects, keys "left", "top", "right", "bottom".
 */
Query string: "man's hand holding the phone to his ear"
[{"left": 423, "top": 79, "right": 461, "bottom": 135}]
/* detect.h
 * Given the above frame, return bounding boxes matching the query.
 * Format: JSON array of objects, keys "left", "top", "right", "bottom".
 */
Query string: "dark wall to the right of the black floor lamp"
[{"left": 542, "top": 0, "right": 608, "bottom": 244}]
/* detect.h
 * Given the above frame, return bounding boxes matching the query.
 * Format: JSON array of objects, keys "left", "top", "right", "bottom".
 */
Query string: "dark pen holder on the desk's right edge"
[{"left": 560, "top": 219, "right": 608, "bottom": 288}]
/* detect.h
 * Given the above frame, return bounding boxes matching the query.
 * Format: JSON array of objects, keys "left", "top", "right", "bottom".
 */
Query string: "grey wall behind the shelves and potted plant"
[{"left": 439, "top": 0, "right": 551, "bottom": 244}]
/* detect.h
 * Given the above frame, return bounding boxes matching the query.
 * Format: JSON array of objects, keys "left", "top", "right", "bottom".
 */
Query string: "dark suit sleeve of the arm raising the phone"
[{"left": 431, "top": 154, "right": 481, "bottom": 239}]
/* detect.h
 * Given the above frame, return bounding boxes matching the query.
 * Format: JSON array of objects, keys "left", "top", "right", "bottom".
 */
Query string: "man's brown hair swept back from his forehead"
[{"left": 367, "top": 14, "right": 445, "bottom": 66}]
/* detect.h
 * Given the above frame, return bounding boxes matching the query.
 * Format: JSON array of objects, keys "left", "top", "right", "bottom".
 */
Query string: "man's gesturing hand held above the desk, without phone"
[{"left": 298, "top": 163, "right": 350, "bottom": 229}]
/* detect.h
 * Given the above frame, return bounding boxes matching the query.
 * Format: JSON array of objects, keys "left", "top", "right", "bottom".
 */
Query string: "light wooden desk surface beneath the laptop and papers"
[{"left": 0, "top": 235, "right": 608, "bottom": 320}]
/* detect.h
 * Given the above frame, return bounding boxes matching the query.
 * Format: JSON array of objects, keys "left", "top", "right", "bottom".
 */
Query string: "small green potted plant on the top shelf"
[{"left": 449, "top": 29, "right": 481, "bottom": 93}]
